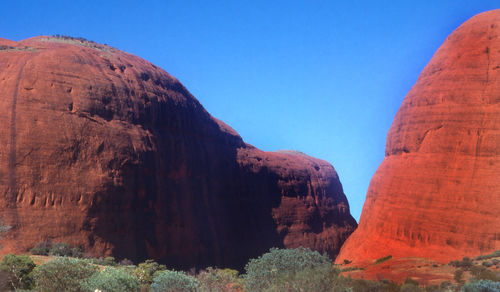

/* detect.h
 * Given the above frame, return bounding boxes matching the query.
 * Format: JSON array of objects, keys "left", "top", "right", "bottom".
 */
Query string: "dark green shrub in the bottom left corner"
[{"left": 0, "top": 254, "right": 36, "bottom": 289}]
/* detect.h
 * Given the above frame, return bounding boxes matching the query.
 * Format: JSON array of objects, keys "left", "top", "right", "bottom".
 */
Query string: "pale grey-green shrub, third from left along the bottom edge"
[{"left": 80, "top": 267, "right": 140, "bottom": 292}]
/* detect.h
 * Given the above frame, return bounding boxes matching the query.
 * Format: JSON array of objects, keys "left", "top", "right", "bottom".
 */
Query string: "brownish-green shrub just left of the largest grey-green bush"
[{"left": 196, "top": 267, "right": 241, "bottom": 292}]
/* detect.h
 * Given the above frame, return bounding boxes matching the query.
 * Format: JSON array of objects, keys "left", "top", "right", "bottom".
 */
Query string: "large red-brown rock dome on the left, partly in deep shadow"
[{"left": 0, "top": 37, "right": 356, "bottom": 268}]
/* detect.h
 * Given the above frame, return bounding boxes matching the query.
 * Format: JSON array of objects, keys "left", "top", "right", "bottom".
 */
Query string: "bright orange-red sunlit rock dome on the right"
[{"left": 337, "top": 10, "right": 500, "bottom": 262}]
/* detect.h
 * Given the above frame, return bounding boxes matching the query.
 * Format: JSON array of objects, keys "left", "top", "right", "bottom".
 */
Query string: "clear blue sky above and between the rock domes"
[{"left": 0, "top": 0, "right": 500, "bottom": 219}]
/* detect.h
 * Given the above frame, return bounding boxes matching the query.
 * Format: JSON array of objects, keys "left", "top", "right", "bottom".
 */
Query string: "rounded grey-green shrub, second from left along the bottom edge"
[{"left": 33, "top": 257, "right": 97, "bottom": 292}]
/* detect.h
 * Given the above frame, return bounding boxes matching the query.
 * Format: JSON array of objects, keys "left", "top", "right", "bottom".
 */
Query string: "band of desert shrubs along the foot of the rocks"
[{"left": 0, "top": 242, "right": 500, "bottom": 292}]
